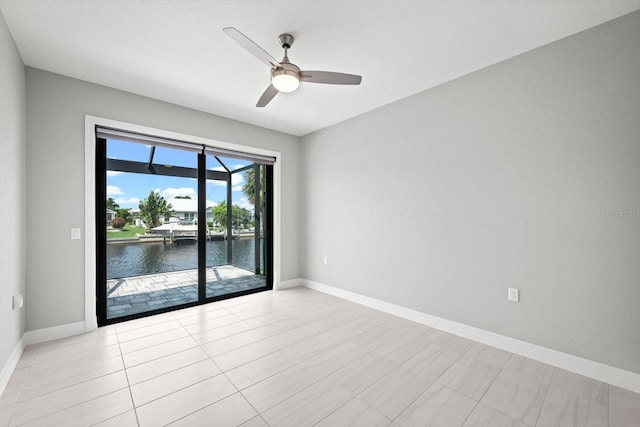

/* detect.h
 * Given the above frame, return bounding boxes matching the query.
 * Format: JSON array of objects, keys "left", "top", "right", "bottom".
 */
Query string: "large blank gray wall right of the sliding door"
[{"left": 301, "top": 12, "right": 640, "bottom": 373}]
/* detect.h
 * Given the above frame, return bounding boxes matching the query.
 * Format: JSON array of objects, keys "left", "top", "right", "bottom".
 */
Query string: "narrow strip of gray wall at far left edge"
[{"left": 0, "top": 13, "right": 26, "bottom": 370}]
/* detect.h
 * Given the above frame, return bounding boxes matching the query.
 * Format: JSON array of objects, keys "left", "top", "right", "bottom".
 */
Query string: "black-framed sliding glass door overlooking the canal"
[{"left": 96, "top": 129, "right": 272, "bottom": 325}]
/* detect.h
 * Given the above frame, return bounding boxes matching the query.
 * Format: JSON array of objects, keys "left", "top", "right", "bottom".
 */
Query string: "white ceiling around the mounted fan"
[{"left": 0, "top": 0, "right": 640, "bottom": 135}]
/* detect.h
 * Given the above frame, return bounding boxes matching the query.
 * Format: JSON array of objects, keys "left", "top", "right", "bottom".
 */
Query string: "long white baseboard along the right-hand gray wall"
[{"left": 298, "top": 279, "right": 640, "bottom": 393}]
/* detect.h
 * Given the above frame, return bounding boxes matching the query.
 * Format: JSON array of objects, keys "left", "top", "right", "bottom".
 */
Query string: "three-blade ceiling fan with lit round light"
[{"left": 222, "top": 27, "right": 362, "bottom": 107}]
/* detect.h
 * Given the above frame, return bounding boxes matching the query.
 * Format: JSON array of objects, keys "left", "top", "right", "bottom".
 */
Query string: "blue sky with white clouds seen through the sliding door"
[{"left": 107, "top": 140, "right": 253, "bottom": 210}]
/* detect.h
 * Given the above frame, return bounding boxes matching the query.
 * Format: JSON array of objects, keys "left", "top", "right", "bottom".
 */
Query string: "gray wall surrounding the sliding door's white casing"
[{"left": 26, "top": 68, "right": 300, "bottom": 330}]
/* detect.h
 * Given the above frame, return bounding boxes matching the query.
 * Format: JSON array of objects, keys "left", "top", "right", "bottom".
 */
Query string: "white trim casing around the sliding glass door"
[{"left": 83, "top": 115, "right": 282, "bottom": 326}]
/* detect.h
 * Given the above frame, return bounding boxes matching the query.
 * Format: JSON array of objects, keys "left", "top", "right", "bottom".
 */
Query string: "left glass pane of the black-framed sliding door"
[{"left": 106, "top": 140, "right": 198, "bottom": 319}]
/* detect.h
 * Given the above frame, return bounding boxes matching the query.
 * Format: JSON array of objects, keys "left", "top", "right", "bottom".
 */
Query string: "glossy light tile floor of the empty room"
[{"left": 0, "top": 288, "right": 640, "bottom": 427}]
